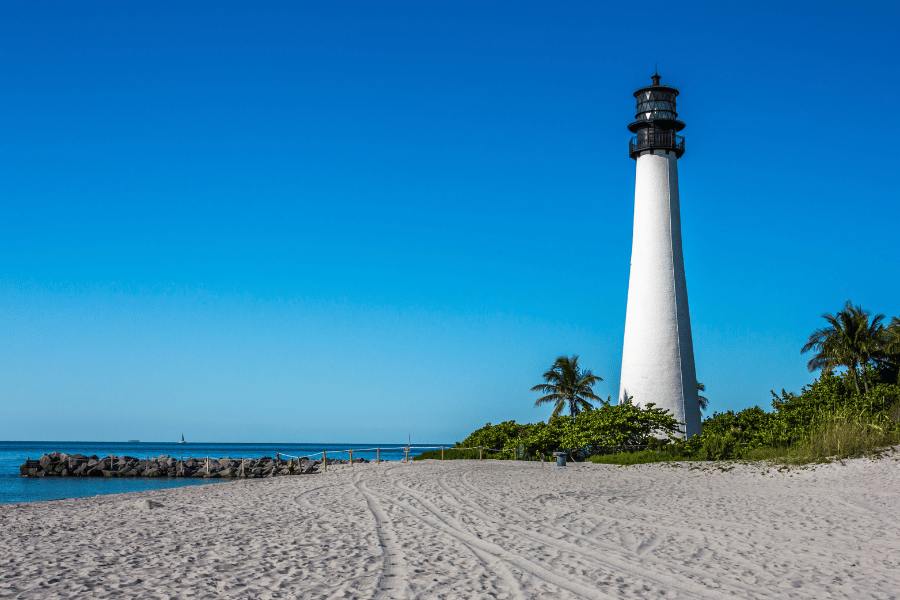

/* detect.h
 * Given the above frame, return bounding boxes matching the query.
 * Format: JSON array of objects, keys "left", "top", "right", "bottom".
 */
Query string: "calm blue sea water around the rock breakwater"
[{"left": 0, "top": 442, "right": 452, "bottom": 504}]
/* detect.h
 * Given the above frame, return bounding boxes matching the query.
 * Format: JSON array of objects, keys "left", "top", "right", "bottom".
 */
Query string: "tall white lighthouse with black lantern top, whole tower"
[{"left": 619, "top": 75, "right": 701, "bottom": 437}]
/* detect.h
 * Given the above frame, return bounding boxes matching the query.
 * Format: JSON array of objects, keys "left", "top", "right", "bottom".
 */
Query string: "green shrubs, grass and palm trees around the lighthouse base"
[{"left": 420, "top": 302, "right": 900, "bottom": 464}]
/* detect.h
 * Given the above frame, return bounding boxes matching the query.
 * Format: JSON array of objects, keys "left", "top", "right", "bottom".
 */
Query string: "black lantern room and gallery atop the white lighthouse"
[{"left": 628, "top": 75, "right": 684, "bottom": 160}]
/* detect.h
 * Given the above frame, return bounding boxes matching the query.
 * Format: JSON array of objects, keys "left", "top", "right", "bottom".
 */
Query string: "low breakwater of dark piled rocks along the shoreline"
[{"left": 19, "top": 452, "right": 369, "bottom": 479}]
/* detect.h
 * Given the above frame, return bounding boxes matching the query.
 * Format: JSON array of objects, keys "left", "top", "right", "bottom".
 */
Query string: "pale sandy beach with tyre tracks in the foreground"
[{"left": 0, "top": 454, "right": 900, "bottom": 599}]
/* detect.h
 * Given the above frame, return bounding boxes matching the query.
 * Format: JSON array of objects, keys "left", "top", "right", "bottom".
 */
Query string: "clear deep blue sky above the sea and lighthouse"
[{"left": 0, "top": 0, "right": 900, "bottom": 442}]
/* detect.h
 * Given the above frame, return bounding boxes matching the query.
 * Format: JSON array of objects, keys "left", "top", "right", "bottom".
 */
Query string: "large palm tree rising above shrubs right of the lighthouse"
[{"left": 800, "top": 300, "right": 885, "bottom": 394}]
